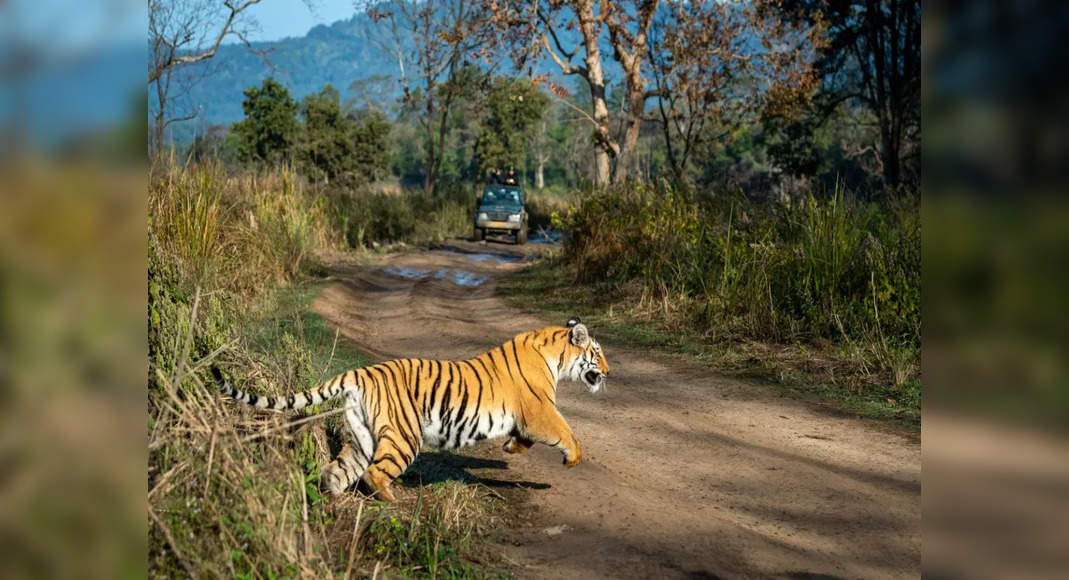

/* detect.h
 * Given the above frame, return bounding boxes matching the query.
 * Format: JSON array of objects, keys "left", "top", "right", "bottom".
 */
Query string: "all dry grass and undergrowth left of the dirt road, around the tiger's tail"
[{"left": 148, "top": 160, "right": 505, "bottom": 578}]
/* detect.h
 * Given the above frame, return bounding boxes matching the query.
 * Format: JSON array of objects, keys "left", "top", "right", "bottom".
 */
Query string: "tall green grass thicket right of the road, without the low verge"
[{"left": 558, "top": 186, "right": 920, "bottom": 385}]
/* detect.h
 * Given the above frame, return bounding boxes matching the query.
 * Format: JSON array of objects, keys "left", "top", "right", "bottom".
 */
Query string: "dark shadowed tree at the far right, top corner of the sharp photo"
[{"left": 783, "top": 0, "right": 920, "bottom": 187}]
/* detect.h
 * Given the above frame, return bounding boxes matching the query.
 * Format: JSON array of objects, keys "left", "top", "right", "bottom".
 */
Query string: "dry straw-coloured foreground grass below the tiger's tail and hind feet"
[{"left": 148, "top": 333, "right": 500, "bottom": 578}]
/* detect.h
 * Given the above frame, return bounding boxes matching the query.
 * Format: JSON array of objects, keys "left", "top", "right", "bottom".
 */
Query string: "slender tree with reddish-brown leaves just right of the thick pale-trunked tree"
[{"left": 648, "top": 0, "right": 823, "bottom": 183}]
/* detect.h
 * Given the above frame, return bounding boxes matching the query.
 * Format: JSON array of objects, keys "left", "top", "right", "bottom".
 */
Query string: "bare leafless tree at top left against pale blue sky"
[{"left": 148, "top": 0, "right": 269, "bottom": 156}]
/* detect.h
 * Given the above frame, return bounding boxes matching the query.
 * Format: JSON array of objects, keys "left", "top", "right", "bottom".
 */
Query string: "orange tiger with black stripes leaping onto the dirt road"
[{"left": 211, "top": 316, "right": 609, "bottom": 502}]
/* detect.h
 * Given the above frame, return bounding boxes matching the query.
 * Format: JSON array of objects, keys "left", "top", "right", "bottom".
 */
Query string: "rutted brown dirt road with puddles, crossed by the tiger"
[{"left": 313, "top": 241, "right": 920, "bottom": 578}]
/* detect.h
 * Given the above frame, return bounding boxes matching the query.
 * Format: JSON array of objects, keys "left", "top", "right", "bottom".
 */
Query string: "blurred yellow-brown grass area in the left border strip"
[{"left": 0, "top": 155, "right": 145, "bottom": 578}]
